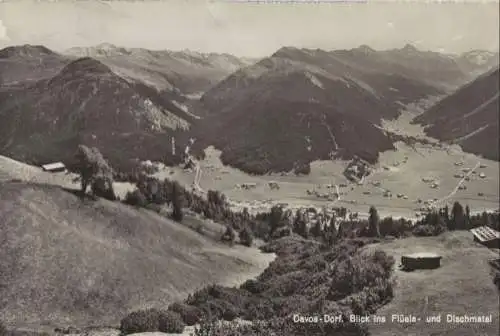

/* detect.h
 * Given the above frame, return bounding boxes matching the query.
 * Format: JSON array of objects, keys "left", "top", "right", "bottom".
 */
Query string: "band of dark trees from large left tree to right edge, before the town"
[{"left": 72, "top": 145, "right": 499, "bottom": 246}]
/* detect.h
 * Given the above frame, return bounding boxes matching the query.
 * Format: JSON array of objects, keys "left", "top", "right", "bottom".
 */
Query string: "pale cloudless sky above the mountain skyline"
[{"left": 0, "top": 0, "right": 499, "bottom": 57}]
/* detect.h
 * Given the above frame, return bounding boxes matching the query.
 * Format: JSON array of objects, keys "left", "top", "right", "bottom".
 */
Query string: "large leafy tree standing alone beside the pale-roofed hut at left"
[{"left": 76, "top": 145, "right": 116, "bottom": 200}]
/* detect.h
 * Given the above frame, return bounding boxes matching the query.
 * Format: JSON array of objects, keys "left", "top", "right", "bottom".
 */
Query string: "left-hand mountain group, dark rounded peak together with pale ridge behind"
[{"left": 0, "top": 45, "right": 262, "bottom": 171}]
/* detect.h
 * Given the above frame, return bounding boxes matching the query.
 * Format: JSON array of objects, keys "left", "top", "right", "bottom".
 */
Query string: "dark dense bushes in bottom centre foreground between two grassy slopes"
[{"left": 121, "top": 235, "right": 394, "bottom": 335}]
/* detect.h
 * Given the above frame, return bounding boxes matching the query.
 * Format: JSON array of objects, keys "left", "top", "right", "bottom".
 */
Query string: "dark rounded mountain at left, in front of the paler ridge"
[{"left": 0, "top": 57, "right": 193, "bottom": 171}]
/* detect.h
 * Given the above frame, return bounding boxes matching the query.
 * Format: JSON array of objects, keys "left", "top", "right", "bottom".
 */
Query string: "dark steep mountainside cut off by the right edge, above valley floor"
[{"left": 415, "top": 68, "right": 499, "bottom": 160}]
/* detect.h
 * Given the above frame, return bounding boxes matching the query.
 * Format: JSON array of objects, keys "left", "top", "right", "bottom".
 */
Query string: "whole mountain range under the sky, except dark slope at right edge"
[{"left": 0, "top": 44, "right": 498, "bottom": 174}]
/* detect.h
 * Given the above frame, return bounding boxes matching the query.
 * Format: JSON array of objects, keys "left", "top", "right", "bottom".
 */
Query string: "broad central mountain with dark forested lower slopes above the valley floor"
[{"left": 191, "top": 47, "right": 454, "bottom": 172}]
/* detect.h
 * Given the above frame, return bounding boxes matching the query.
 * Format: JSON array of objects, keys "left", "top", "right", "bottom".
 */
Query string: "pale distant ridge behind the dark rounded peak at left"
[{"left": 65, "top": 43, "right": 254, "bottom": 94}]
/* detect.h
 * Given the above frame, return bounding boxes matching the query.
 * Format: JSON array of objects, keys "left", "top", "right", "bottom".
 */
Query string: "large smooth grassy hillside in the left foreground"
[{"left": 0, "top": 183, "right": 274, "bottom": 326}]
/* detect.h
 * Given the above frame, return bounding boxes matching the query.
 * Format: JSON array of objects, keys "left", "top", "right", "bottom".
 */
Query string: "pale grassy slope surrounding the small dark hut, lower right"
[{"left": 367, "top": 232, "right": 499, "bottom": 336}]
